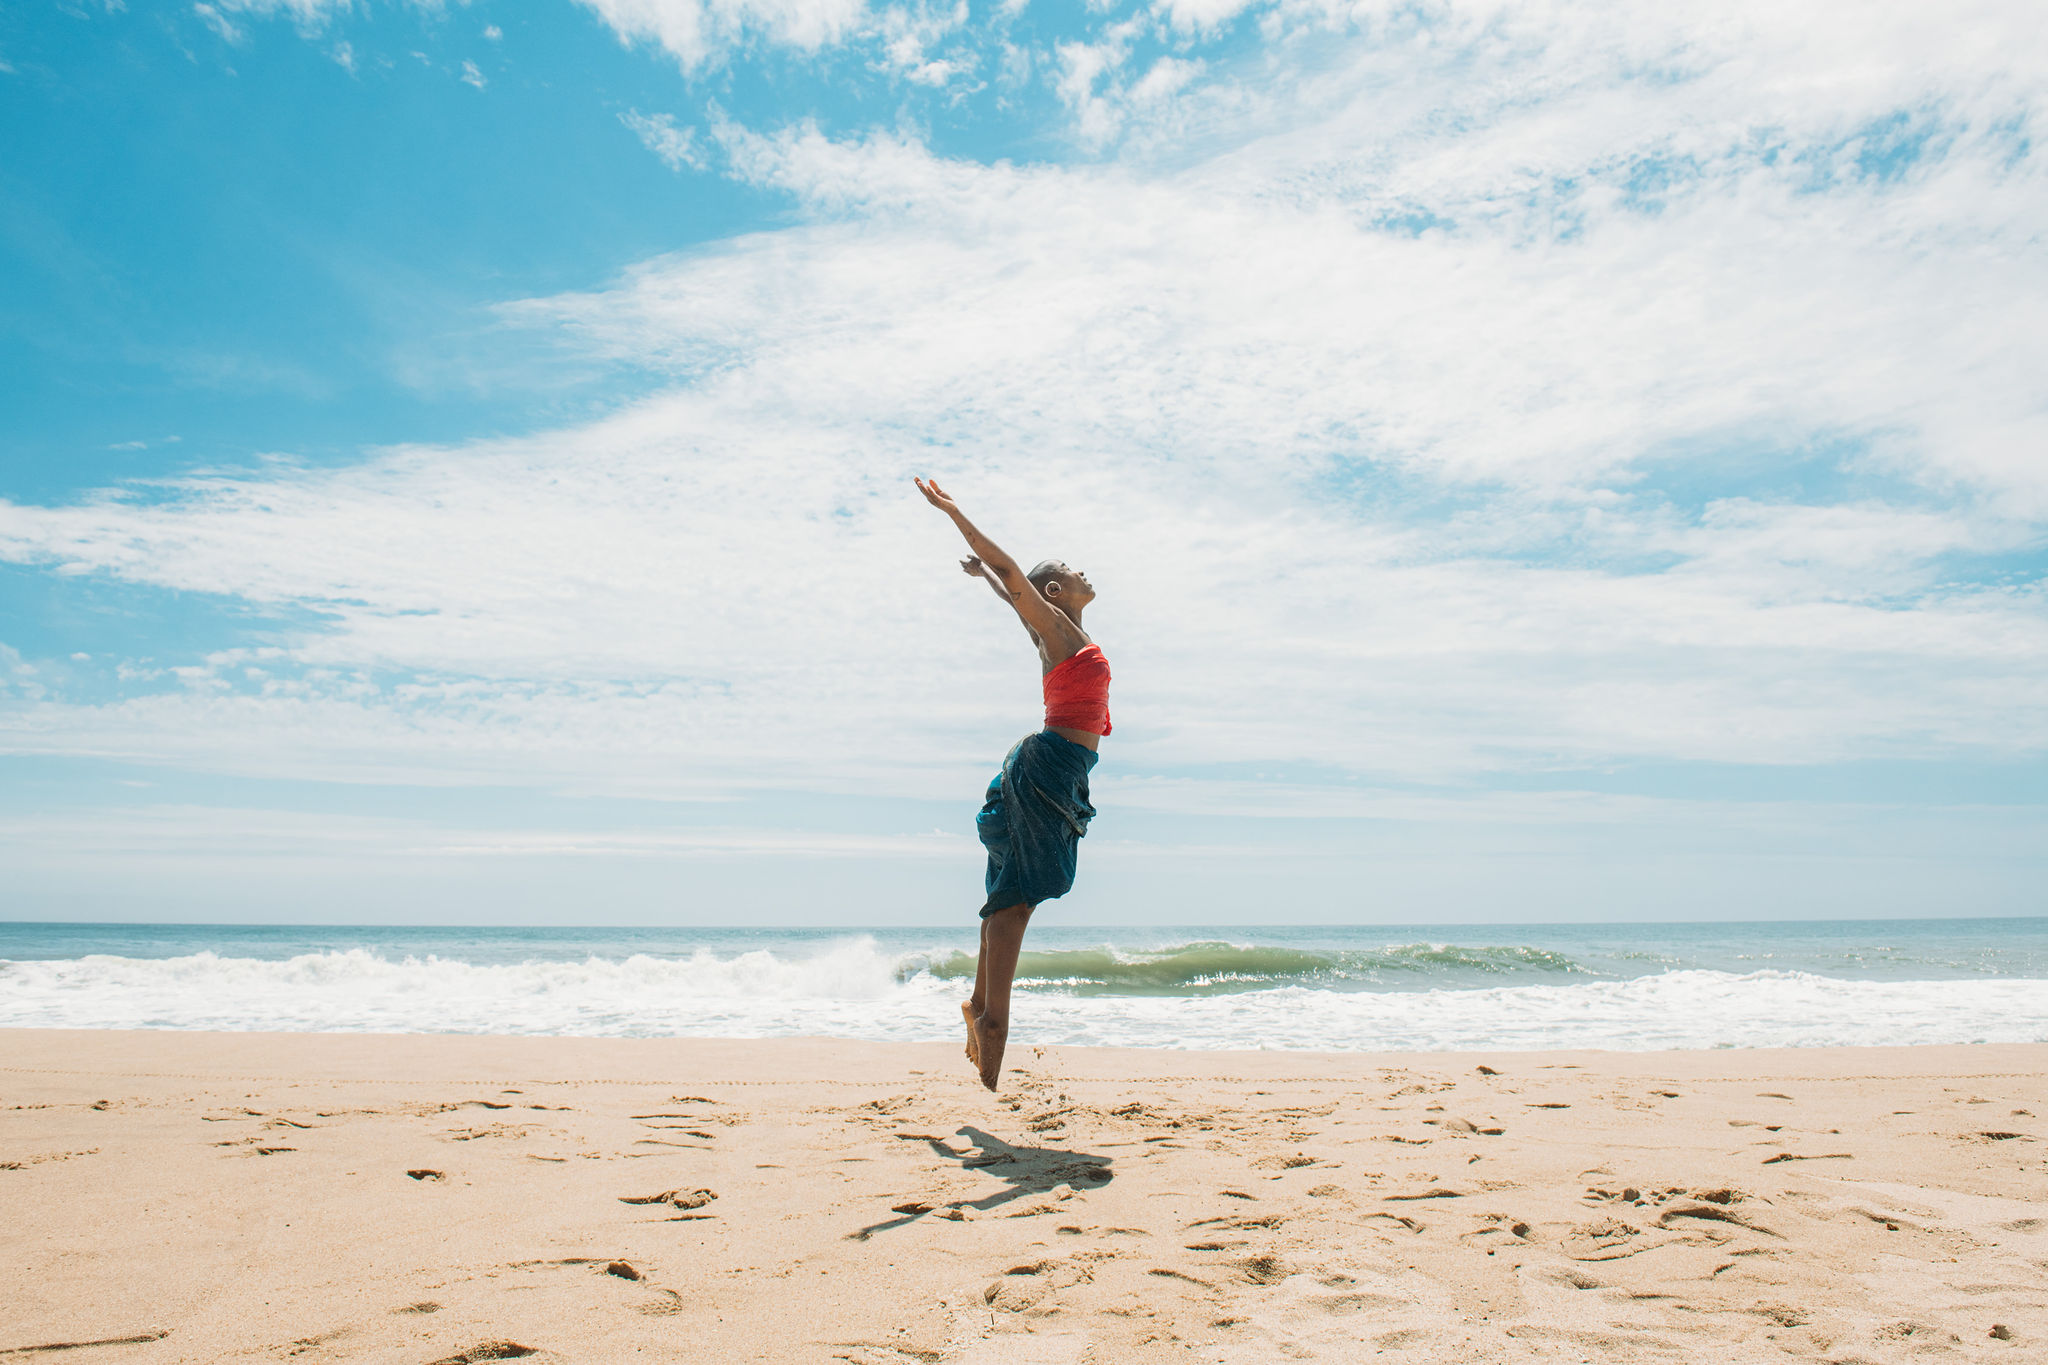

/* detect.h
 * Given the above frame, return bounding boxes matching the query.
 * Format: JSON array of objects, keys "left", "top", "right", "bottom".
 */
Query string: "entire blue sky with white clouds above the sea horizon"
[{"left": 0, "top": 0, "right": 2048, "bottom": 925}]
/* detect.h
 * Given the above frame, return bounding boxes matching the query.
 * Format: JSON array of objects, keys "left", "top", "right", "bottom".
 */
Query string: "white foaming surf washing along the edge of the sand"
[{"left": 0, "top": 939, "right": 2048, "bottom": 1052}]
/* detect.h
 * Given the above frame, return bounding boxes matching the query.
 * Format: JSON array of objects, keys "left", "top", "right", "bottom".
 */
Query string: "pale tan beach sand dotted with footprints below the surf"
[{"left": 0, "top": 1031, "right": 2048, "bottom": 1365}]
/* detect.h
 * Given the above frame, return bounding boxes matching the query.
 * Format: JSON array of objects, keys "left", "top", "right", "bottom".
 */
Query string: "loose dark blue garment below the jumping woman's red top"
[{"left": 975, "top": 731, "right": 1098, "bottom": 919}]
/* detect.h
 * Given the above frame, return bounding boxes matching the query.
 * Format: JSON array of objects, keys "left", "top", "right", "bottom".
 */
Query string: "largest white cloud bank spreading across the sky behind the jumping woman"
[{"left": 0, "top": 8, "right": 2048, "bottom": 810}]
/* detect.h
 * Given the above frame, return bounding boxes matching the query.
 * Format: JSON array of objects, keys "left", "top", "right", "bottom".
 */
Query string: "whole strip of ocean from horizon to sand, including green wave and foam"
[{"left": 0, "top": 917, "right": 2048, "bottom": 1052}]
